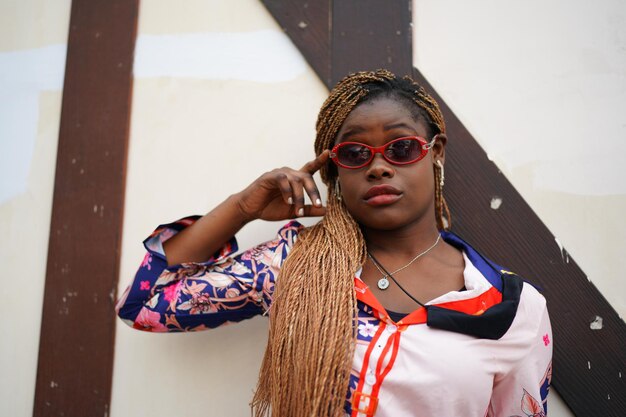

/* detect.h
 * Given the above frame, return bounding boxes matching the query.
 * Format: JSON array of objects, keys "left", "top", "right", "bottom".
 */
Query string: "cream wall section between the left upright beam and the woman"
[{"left": 111, "top": 0, "right": 327, "bottom": 417}]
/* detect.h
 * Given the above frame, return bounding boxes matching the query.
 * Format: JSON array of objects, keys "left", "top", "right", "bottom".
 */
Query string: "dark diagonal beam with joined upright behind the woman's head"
[{"left": 263, "top": 0, "right": 626, "bottom": 416}]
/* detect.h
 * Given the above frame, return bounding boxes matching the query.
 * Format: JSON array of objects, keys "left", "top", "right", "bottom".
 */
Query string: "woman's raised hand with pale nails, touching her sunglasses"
[{"left": 235, "top": 151, "right": 329, "bottom": 221}]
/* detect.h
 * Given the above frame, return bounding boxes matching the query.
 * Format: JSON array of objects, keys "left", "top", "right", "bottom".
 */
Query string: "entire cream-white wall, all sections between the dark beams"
[{"left": 0, "top": 0, "right": 626, "bottom": 417}]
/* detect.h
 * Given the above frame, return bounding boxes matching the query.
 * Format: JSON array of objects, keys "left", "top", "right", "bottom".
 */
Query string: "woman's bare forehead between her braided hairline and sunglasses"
[{"left": 336, "top": 97, "right": 427, "bottom": 142}]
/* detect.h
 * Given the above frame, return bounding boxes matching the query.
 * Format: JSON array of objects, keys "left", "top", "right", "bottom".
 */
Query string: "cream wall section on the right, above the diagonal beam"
[{"left": 413, "top": 0, "right": 626, "bottom": 416}]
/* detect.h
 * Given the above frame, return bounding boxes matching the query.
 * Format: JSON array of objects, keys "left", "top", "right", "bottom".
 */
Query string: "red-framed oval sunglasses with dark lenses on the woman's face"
[{"left": 330, "top": 136, "right": 437, "bottom": 169}]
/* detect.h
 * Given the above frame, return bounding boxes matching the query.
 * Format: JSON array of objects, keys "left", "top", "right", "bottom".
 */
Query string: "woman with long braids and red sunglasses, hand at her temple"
[{"left": 118, "top": 70, "right": 552, "bottom": 417}]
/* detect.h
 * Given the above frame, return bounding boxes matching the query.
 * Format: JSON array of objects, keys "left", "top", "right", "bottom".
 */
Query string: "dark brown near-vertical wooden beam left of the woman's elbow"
[{"left": 33, "top": 0, "right": 139, "bottom": 416}]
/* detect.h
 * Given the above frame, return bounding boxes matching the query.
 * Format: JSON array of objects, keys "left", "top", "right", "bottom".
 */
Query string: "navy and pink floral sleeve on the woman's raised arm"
[{"left": 116, "top": 216, "right": 303, "bottom": 332}]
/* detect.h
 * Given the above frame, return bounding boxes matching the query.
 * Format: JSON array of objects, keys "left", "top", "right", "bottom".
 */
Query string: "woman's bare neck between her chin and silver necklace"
[{"left": 362, "top": 221, "right": 439, "bottom": 257}]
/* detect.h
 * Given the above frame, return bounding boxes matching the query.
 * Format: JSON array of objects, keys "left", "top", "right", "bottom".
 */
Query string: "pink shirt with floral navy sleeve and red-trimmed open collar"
[{"left": 117, "top": 217, "right": 552, "bottom": 417}]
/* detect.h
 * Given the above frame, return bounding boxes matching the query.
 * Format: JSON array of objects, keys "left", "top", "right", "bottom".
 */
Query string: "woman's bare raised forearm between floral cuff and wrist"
[{"left": 163, "top": 194, "right": 250, "bottom": 266}]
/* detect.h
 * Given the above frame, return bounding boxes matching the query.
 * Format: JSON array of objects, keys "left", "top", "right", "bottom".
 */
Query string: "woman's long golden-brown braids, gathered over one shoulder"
[{"left": 252, "top": 70, "right": 450, "bottom": 417}]
